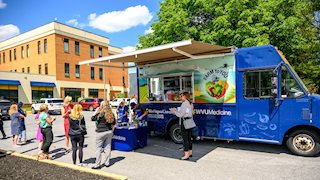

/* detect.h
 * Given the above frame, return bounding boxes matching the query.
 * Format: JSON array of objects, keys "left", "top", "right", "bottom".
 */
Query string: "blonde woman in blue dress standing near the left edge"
[{"left": 9, "top": 104, "right": 24, "bottom": 147}]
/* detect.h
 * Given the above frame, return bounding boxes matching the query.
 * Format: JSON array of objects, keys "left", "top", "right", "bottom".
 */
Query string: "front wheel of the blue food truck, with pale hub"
[{"left": 286, "top": 129, "right": 320, "bottom": 157}]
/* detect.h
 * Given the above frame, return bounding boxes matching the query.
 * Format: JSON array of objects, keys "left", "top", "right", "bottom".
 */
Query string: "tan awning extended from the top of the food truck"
[{"left": 79, "top": 40, "right": 232, "bottom": 65}]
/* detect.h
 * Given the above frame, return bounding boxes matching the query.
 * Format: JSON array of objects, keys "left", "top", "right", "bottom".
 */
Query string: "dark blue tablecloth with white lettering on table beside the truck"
[{"left": 111, "top": 126, "right": 148, "bottom": 151}]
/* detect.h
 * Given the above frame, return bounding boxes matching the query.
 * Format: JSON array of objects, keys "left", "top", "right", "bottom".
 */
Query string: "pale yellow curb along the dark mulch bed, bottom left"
[{"left": 6, "top": 151, "right": 128, "bottom": 180}]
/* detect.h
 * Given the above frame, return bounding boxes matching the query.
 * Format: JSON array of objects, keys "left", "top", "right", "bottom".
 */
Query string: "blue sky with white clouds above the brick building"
[{"left": 0, "top": 0, "right": 162, "bottom": 52}]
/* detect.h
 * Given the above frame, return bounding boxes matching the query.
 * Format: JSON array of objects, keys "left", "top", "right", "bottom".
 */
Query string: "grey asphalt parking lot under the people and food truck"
[{"left": 0, "top": 112, "right": 320, "bottom": 180}]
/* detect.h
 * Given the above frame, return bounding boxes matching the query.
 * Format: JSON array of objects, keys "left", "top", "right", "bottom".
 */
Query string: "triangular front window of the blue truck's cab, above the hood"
[{"left": 281, "top": 66, "right": 305, "bottom": 98}]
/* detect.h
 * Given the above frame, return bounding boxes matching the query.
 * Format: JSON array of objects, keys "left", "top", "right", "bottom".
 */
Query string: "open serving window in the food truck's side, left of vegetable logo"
[{"left": 148, "top": 75, "right": 193, "bottom": 102}]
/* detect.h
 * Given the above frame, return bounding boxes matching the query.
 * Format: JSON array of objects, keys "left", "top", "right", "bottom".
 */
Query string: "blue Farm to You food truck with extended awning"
[{"left": 82, "top": 40, "right": 320, "bottom": 156}]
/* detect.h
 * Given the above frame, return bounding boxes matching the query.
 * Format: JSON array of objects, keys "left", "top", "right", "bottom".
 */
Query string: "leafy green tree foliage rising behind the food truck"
[{"left": 138, "top": 0, "right": 320, "bottom": 92}]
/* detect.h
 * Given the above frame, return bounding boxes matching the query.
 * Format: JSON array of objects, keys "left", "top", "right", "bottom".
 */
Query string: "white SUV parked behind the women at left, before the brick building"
[{"left": 31, "top": 98, "right": 63, "bottom": 114}]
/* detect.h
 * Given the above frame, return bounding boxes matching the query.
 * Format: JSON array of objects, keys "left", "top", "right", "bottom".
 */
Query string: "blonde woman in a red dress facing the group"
[{"left": 61, "top": 96, "right": 72, "bottom": 154}]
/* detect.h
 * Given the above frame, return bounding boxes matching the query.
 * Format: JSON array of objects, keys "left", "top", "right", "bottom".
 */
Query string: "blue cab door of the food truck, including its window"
[{"left": 237, "top": 68, "right": 279, "bottom": 143}]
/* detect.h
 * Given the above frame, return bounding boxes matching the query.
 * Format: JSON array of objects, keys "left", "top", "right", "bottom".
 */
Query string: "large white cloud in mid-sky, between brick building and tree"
[{"left": 88, "top": 5, "right": 152, "bottom": 33}]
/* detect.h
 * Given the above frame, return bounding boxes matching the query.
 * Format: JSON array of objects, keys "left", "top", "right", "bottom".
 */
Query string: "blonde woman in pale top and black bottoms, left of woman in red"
[{"left": 39, "top": 104, "right": 56, "bottom": 159}]
